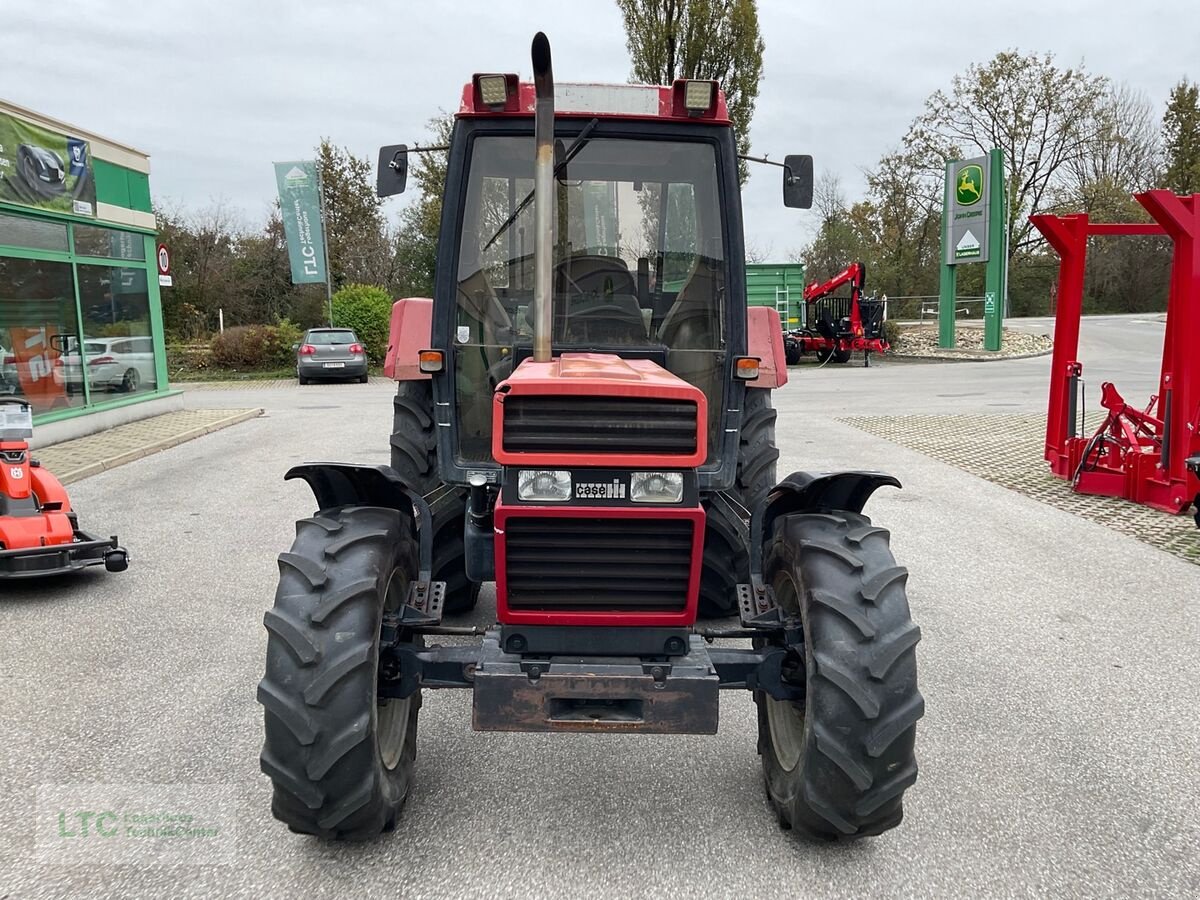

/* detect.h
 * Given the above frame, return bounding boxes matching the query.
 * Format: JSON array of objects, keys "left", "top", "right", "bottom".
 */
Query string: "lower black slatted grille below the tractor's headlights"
[{"left": 504, "top": 517, "right": 695, "bottom": 612}]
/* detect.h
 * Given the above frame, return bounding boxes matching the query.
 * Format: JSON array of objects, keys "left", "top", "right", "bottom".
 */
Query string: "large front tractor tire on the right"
[{"left": 755, "top": 512, "right": 925, "bottom": 840}]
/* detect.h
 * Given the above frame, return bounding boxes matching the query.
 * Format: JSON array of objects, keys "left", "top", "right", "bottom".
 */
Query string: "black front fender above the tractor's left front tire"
[{"left": 283, "top": 462, "right": 433, "bottom": 582}]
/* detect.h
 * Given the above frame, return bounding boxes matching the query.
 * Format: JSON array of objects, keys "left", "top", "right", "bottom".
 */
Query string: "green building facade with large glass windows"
[{"left": 0, "top": 100, "right": 172, "bottom": 424}]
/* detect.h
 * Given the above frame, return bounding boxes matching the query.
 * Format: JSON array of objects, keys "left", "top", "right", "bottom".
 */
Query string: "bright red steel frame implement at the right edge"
[{"left": 1031, "top": 191, "right": 1200, "bottom": 514}]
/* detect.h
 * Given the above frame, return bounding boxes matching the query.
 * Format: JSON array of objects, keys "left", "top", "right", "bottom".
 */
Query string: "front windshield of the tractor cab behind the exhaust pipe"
[{"left": 454, "top": 136, "right": 725, "bottom": 461}]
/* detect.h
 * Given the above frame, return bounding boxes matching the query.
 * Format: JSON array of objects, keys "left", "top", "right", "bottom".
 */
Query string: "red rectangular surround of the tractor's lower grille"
[{"left": 494, "top": 503, "right": 704, "bottom": 626}]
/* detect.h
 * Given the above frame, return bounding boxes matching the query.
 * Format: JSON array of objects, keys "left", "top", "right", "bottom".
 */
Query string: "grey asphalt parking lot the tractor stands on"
[{"left": 0, "top": 314, "right": 1200, "bottom": 898}]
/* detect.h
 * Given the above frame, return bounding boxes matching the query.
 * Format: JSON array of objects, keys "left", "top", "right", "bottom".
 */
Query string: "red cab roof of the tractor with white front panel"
[{"left": 457, "top": 74, "right": 730, "bottom": 125}]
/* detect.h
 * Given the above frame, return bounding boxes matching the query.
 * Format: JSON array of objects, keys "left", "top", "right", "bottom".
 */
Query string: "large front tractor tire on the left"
[{"left": 258, "top": 506, "right": 421, "bottom": 840}]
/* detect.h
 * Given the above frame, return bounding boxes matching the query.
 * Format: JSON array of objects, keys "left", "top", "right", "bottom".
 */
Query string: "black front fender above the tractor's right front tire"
[{"left": 750, "top": 472, "right": 901, "bottom": 578}]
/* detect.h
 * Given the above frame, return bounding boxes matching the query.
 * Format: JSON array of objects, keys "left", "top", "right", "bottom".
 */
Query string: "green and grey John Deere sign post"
[{"left": 937, "top": 150, "right": 1008, "bottom": 350}]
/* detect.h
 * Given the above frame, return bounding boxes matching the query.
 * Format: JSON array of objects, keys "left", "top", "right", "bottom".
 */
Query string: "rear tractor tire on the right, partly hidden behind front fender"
[{"left": 700, "top": 388, "right": 779, "bottom": 618}]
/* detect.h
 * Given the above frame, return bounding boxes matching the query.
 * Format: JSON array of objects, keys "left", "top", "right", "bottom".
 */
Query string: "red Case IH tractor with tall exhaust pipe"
[{"left": 258, "top": 34, "right": 923, "bottom": 839}]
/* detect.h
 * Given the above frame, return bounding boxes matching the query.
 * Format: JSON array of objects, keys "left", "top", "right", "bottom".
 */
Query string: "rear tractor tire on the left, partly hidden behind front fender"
[{"left": 391, "top": 380, "right": 480, "bottom": 613}]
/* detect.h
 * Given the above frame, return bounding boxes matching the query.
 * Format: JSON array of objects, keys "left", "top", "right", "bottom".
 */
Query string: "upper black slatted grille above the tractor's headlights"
[{"left": 504, "top": 394, "right": 703, "bottom": 456}]
